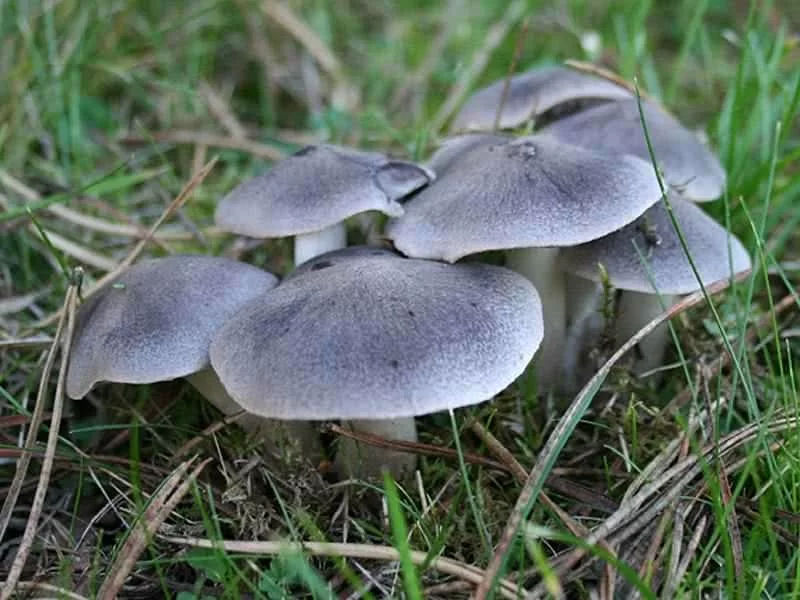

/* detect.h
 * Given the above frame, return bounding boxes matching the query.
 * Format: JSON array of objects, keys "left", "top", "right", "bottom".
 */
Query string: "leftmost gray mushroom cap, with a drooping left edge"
[{"left": 66, "top": 256, "right": 278, "bottom": 398}]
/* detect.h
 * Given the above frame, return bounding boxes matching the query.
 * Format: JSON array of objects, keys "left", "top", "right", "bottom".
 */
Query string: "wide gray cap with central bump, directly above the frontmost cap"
[{"left": 386, "top": 134, "right": 661, "bottom": 262}]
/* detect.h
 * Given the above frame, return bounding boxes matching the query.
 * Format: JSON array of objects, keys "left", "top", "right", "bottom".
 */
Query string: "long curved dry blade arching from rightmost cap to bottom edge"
[{"left": 475, "top": 271, "right": 750, "bottom": 600}]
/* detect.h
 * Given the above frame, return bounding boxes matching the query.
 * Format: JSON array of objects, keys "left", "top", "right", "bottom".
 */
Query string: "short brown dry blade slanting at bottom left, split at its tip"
[{"left": 97, "top": 458, "right": 211, "bottom": 600}]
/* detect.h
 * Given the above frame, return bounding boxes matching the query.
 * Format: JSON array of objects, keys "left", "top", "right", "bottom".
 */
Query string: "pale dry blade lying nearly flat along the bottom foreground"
[{"left": 160, "top": 536, "right": 523, "bottom": 600}]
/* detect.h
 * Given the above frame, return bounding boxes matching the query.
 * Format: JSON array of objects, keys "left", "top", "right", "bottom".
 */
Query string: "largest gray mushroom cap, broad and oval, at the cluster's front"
[{"left": 211, "top": 247, "right": 542, "bottom": 420}]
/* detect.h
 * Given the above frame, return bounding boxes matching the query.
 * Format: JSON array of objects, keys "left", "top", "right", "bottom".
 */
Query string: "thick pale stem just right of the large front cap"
[{"left": 506, "top": 248, "right": 567, "bottom": 393}]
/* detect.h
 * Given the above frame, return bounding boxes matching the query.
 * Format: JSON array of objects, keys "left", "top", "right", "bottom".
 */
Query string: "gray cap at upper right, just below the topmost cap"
[{"left": 541, "top": 98, "right": 725, "bottom": 202}]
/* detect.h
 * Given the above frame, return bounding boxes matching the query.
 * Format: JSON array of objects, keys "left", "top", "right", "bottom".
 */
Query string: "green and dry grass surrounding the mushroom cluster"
[{"left": 0, "top": 0, "right": 800, "bottom": 600}]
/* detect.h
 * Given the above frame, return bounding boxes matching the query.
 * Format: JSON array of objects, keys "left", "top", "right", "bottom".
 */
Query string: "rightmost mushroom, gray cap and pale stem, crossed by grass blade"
[{"left": 561, "top": 192, "right": 751, "bottom": 380}]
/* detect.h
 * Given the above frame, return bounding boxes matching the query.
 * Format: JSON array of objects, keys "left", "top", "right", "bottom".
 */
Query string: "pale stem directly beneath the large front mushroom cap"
[{"left": 336, "top": 417, "right": 417, "bottom": 479}]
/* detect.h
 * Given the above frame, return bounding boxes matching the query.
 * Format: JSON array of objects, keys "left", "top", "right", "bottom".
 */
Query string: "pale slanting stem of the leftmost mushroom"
[{"left": 185, "top": 367, "right": 322, "bottom": 464}]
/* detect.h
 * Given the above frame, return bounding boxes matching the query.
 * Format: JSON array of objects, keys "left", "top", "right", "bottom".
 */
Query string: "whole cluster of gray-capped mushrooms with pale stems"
[{"left": 67, "top": 62, "right": 750, "bottom": 476}]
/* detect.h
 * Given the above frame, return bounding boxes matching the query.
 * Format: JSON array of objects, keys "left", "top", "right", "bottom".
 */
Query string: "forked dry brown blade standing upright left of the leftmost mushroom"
[{"left": 0, "top": 269, "right": 81, "bottom": 600}]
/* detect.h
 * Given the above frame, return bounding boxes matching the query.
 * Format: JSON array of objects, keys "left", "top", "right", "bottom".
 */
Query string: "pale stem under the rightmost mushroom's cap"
[{"left": 615, "top": 291, "right": 679, "bottom": 373}]
